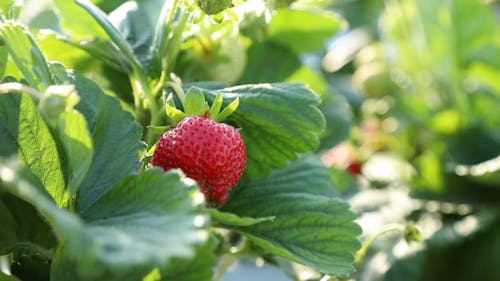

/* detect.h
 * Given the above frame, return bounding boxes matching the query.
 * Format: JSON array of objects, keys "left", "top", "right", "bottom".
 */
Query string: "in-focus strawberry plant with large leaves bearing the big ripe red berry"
[{"left": 0, "top": 0, "right": 361, "bottom": 281}]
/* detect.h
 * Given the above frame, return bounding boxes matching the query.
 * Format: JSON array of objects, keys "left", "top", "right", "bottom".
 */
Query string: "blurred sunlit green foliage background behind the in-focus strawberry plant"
[{"left": 0, "top": 0, "right": 500, "bottom": 281}]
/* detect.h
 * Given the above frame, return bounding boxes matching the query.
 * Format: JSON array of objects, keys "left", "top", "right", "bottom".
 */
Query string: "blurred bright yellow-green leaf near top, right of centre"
[{"left": 268, "top": 9, "right": 346, "bottom": 54}]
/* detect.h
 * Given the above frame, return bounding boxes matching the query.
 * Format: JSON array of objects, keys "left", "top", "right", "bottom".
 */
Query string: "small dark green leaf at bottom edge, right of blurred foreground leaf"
[{"left": 161, "top": 236, "right": 216, "bottom": 281}]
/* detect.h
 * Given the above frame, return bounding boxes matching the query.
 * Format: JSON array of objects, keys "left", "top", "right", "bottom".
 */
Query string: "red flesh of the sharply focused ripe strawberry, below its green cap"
[{"left": 151, "top": 116, "right": 246, "bottom": 204}]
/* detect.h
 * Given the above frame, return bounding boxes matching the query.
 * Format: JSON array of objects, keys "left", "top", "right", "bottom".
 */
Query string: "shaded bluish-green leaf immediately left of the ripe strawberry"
[{"left": 59, "top": 69, "right": 143, "bottom": 211}]
